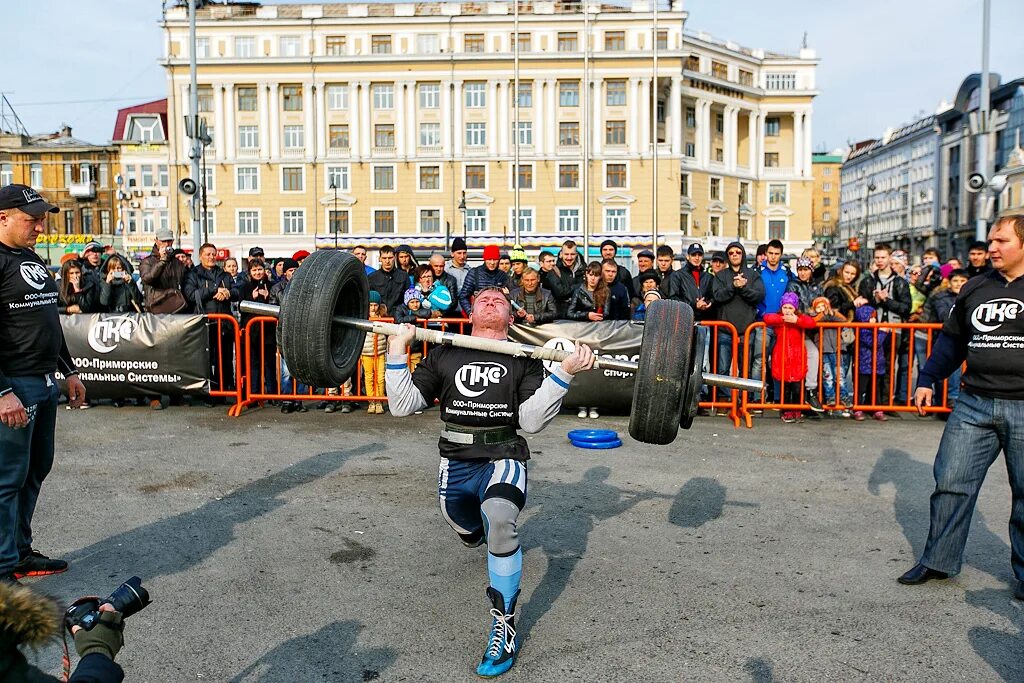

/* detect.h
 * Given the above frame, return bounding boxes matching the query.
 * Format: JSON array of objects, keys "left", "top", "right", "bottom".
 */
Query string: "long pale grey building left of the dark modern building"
[{"left": 839, "top": 116, "right": 940, "bottom": 254}]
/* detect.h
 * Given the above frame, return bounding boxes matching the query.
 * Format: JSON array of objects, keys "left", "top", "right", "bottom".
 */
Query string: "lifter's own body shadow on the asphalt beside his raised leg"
[{"left": 516, "top": 465, "right": 669, "bottom": 641}]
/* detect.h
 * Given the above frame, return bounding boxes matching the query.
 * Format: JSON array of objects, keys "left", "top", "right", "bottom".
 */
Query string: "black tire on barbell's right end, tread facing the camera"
[{"left": 630, "top": 300, "right": 693, "bottom": 444}]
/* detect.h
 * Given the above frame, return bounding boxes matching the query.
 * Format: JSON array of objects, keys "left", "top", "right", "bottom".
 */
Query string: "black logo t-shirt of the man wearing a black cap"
[{"left": 0, "top": 244, "right": 74, "bottom": 391}]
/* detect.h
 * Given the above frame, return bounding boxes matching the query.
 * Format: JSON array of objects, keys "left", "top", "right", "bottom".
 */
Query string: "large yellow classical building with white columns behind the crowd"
[{"left": 157, "top": 0, "right": 817, "bottom": 255}]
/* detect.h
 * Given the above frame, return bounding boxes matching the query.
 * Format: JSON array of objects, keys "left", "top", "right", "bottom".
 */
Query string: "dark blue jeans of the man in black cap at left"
[{"left": 0, "top": 375, "right": 59, "bottom": 574}]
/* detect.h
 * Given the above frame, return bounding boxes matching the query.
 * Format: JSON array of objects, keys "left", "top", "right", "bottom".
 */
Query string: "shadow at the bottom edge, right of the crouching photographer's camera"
[{"left": 230, "top": 620, "right": 396, "bottom": 683}]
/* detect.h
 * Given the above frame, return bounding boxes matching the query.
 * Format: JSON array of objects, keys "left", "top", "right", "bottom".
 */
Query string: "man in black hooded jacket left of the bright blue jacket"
[{"left": 712, "top": 242, "right": 765, "bottom": 399}]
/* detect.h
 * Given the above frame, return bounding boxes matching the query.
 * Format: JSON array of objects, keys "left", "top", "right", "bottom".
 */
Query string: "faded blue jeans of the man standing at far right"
[{"left": 921, "top": 392, "right": 1024, "bottom": 581}]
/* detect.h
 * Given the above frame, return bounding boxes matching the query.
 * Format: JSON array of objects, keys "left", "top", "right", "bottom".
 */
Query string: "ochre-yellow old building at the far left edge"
[{"left": 0, "top": 120, "right": 118, "bottom": 262}]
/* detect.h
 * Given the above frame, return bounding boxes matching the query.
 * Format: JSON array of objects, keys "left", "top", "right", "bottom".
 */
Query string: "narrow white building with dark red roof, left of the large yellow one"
[{"left": 112, "top": 99, "right": 172, "bottom": 260}]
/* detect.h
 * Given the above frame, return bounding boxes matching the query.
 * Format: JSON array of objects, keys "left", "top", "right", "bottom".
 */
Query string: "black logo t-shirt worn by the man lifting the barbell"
[{"left": 413, "top": 346, "right": 544, "bottom": 461}]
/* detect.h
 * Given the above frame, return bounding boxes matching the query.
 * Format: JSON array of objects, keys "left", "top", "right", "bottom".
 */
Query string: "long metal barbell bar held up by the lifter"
[{"left": 239, "top": 301, "right": 763, "bottom": 391}]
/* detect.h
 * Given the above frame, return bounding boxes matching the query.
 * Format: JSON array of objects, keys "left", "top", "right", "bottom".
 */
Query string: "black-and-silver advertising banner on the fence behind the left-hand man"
[{"left": 60, "top": 313, "right": 210, "bottom": 398}]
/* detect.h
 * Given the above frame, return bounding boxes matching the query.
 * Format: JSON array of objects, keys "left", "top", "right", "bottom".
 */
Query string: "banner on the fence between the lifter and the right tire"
[{"left": 509, "top": 321, "right": 643, "bottom": 415}]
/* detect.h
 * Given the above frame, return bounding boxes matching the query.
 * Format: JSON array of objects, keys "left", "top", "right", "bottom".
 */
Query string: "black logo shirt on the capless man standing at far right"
[{"left": 942, "top": 270, "right": 1024, "bottom": 400}]
